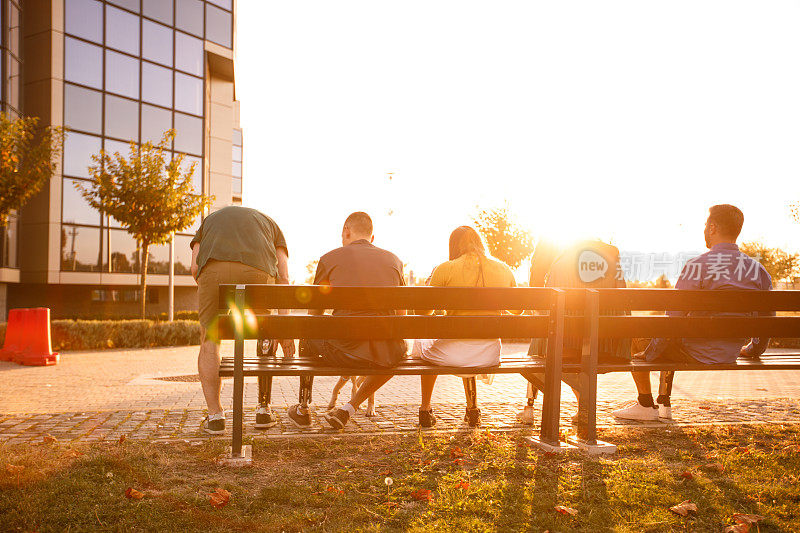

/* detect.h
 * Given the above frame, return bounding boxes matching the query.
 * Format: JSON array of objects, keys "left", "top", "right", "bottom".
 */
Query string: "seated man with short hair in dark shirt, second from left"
[{"left": 288, "top": 212, "right": 406, "bottom": 429}]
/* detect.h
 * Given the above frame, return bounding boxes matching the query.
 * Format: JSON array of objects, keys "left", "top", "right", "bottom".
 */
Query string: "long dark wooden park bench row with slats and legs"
[{"left": 218, "top": 285, "right": 800, "bottom": 457}]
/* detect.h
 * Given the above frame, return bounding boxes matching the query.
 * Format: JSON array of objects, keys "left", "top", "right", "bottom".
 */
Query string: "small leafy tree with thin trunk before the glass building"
[{"left": 76, "top": 130, "right": 211, "bottom": 318}]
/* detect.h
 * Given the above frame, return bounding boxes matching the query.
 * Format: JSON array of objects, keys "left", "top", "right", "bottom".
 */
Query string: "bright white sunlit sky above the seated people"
[{"left": 235, "top": 0, "right": 800, "bottom": 282}]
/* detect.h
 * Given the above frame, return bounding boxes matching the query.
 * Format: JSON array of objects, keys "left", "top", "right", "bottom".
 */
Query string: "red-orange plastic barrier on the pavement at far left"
[{"left": 3, "top": 307, "right": 58, "bottom": 366}]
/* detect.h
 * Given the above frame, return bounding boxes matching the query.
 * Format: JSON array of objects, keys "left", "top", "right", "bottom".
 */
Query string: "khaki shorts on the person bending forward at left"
[{"left": 197, "top": 260, "right": 275, "bottom": 340}]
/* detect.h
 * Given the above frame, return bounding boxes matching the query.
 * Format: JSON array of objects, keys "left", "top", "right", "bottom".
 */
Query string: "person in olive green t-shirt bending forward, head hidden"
[{"left": 190, "top": 206, "right": 294, "bottom": 434}]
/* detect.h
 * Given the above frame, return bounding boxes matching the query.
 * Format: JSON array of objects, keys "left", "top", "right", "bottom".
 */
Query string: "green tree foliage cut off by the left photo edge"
[{"left": 0, "top": 113, "right": 63, "bottom": 227}]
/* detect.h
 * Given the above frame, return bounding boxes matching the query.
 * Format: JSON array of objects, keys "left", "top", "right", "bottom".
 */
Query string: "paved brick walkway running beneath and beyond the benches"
[{"left": 0, "top": 344, "right": 800, "bottom": 442}]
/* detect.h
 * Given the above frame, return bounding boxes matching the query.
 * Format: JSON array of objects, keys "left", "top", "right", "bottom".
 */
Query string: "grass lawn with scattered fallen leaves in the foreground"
[{"left": 0, "top": 425, "right": 800, "bottom": 532}]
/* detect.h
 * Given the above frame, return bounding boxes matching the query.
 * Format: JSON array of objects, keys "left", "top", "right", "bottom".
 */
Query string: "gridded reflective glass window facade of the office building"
[{"left": 59, "top": 0, "right": 233, "bottom": 274}]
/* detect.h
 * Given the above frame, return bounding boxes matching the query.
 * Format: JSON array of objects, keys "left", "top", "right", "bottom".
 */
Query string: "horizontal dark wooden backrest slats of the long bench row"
[{"left": 219, "top": 285, "right": 800, "bottom": 339}]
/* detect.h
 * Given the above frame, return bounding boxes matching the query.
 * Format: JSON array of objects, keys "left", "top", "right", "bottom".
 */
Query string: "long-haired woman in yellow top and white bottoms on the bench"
[{"left": 412, "top": 226, "right": 516, "bottom": 427}]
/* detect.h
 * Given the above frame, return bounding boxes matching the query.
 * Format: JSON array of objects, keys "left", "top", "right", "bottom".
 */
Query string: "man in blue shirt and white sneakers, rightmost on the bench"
[{"left": 612, "top": 204, "right": 774, "bottom": 420}]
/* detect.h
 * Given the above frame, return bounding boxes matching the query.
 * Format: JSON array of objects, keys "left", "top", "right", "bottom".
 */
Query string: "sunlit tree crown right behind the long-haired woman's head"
[{"left": 473, "top": 206, "right": 533, "bottom": 269}]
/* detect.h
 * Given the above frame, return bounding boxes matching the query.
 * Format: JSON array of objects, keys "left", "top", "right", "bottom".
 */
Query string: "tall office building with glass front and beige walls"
[{"left": 6, "top": 0, "right": 242, "bottom": 316}]
